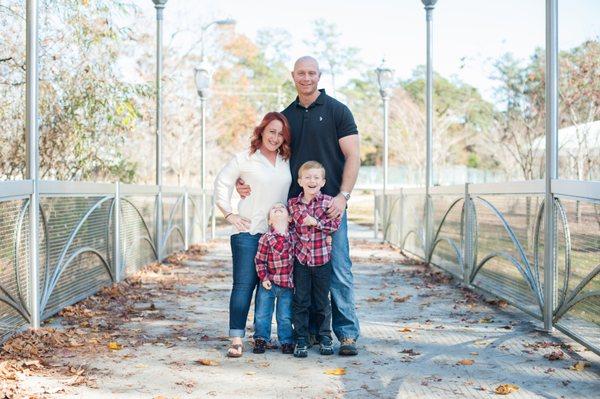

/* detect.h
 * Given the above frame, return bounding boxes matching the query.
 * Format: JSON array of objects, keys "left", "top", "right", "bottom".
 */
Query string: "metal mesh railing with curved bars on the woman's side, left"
[{"left": 0, "top": 180, "right": 214, "bottom": 342}]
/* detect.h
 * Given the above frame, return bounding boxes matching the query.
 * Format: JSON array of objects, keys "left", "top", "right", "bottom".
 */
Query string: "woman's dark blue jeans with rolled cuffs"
[{"left": 229, "top": 233, "right": 261, "bottom": 338}]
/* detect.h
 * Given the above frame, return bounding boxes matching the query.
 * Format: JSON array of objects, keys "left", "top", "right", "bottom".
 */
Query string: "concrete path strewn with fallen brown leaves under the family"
[{"left": 0, "top": 226, "right": 600, "bottom": 399}]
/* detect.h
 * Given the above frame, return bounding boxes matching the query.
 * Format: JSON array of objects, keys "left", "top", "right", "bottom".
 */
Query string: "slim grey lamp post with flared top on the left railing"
[{"left": 152, "top": 0, "right": 168, "bottom": 261}]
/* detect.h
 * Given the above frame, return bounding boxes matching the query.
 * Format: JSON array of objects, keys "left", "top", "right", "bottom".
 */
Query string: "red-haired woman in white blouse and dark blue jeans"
[{"left": 215, "top": 112, "right": 292, "bottom": 357}]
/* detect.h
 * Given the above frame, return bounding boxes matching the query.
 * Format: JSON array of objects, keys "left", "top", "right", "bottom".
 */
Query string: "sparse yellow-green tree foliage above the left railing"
[{"left": 0, "top": 0, "right": 151, "bottom": 182}]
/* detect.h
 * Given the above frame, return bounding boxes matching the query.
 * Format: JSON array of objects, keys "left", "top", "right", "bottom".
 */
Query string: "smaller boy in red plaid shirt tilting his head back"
[{"left": 253, "top": 203, "right": 294, "bottom": 354}]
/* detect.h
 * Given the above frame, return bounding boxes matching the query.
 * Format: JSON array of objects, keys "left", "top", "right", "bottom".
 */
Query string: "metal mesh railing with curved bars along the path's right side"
[{"left": 375, "top": 180, "right": 600, "bottom": 354}]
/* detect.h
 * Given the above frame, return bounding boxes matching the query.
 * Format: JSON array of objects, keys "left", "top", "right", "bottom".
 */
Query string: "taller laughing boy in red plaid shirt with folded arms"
[{"left": 288, "top": 161, "right": 341, "bottom": 357}]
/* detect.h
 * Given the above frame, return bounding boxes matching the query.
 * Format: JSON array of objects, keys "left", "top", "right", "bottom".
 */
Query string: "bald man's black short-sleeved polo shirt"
[{"left": 282, "top": 89, "right": 358, "bottom": 198}]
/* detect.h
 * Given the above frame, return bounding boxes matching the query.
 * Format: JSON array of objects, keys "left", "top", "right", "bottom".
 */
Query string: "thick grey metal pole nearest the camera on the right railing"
[{"left": 544, "top": 0, "right": 558, "bottom": 332}]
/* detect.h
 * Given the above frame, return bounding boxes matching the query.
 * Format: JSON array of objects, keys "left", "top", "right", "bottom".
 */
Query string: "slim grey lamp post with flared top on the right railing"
[{"left": 421, "top": 0, "right": 437, "bottom": 258}]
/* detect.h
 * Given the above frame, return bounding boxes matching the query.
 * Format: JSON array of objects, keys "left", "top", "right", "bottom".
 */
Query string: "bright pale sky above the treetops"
[{"left": 156, "top": 0, "right": 600, "bottom": 98}]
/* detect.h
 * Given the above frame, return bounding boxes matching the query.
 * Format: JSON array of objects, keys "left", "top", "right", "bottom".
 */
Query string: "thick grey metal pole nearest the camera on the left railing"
[{"left": 25, "top": 0, "right": 39, "bottom": 329}]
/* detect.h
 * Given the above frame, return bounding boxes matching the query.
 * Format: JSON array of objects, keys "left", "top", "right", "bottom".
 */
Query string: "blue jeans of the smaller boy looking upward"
[{"left": 254, "top": 284, "right": 294, "bottom": 344}]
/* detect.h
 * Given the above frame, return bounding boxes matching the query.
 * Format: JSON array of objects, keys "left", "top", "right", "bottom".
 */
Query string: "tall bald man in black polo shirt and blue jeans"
[{"left": 237, "top": 56, "right": 360, "bottom": 356}]
